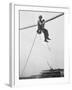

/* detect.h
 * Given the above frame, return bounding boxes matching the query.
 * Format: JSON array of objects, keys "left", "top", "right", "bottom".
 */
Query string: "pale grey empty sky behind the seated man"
[{"left": 19, "top": 11, "right": 64, "bottom": 77}]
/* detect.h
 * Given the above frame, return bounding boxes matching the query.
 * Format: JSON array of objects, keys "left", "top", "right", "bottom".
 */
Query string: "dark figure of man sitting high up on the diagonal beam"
[{"left": 37, "top": 15, "right": 51, "bottom": 42}]
